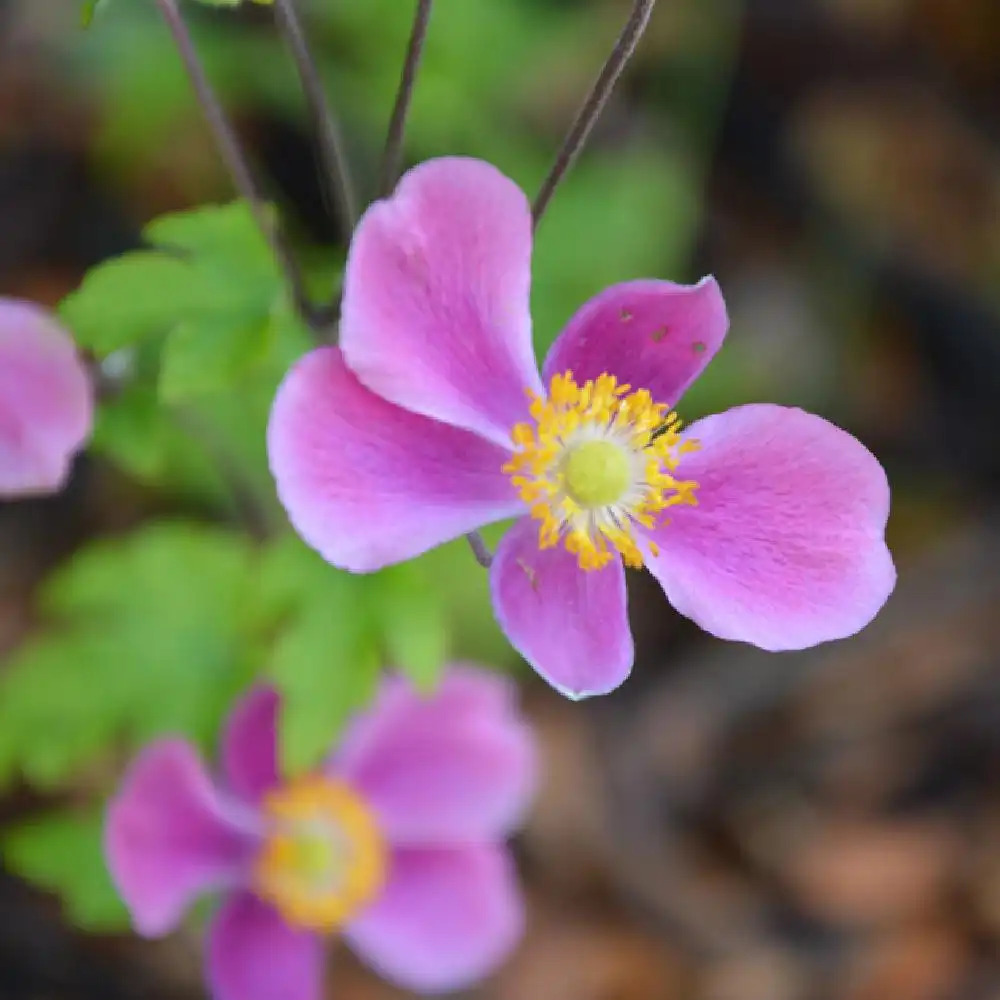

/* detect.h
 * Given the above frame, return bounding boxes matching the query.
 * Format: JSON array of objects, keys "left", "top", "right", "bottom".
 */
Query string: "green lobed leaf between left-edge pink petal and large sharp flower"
[{"left": 60, "top": 202, "right": 312, "bottom": 508}]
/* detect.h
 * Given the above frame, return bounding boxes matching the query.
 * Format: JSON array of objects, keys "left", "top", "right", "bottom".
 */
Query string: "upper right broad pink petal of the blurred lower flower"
[{"left": 332, "top": 667, "right": 535, "bottom": 845}]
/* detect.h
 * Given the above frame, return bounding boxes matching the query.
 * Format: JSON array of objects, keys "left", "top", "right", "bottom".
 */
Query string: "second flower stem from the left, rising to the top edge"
[{"left": 274, "top": 0, "right": 358, "bottom": 234}]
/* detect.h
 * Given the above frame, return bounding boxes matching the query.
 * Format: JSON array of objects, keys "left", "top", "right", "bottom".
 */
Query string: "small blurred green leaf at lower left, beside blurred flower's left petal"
[{"left": 0, "top": 811, "right": 128, "bottom": 933}]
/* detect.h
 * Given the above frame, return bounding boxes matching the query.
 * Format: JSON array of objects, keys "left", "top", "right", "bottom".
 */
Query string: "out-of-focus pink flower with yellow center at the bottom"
[{"left": 105, "top": 667, "right": 534, "bottom": 1000}]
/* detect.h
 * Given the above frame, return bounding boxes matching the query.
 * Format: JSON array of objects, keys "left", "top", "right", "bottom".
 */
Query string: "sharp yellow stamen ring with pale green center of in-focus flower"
[{"left": 503, "top": 372, "right": 698, "bottom": 570}]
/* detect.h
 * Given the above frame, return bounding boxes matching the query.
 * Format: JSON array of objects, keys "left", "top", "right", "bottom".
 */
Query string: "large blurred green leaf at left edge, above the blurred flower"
[{"left": 0, "top": 522, "right": 269, "bottom": 788}]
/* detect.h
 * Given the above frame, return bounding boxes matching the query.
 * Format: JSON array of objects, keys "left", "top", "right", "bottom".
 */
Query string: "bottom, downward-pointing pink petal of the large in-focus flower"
[{"left": 490, "top": 518, "right": 634, "bottom": 699}]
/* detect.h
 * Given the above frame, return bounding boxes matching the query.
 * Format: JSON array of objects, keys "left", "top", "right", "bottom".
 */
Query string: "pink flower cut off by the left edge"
[{"left": 0, "top": 299, "right": 94, "bottom": 497}]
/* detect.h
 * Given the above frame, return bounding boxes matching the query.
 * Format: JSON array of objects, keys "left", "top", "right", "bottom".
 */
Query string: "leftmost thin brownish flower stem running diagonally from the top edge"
[{"left": 156, "top": 0, "right": 316, "bottom": 326}]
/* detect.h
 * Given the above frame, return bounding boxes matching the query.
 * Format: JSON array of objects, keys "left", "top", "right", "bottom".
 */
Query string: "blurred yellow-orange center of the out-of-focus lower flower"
[{"left": 253, "top": 776, "right": 385, "bottom": 931}]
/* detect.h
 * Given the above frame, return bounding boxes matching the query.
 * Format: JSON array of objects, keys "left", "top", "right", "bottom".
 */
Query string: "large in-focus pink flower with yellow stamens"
[{"left": 268, "top": 159, "right": 895, "bottom": 698}]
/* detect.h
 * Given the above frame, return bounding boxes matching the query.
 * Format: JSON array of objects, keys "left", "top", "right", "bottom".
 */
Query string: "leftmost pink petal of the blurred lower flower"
[{"left": 104, "top": 740, "right": 254, "bottom": 937}]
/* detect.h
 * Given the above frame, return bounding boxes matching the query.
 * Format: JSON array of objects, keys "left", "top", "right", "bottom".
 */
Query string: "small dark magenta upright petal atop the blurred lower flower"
[{"left": 222, "top": 685, "right": 280, "bottom": 803}]
